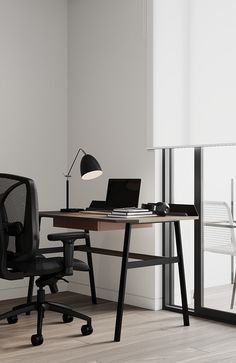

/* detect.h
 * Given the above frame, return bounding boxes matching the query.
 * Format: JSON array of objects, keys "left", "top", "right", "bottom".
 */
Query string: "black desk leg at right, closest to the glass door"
[{"left": 174, "top": 221, "right": 189, "bottom": 326}]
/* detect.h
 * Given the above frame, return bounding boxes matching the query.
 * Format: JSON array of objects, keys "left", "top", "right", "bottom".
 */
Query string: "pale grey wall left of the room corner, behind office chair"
[{"left": 0, "top": 0, "right": 67, "bottom": 299}]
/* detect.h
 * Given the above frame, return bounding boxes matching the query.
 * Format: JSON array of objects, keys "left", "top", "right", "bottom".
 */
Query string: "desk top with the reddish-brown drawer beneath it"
[{"left": 39, "top": 211, "right": 198, "bottom": 230}]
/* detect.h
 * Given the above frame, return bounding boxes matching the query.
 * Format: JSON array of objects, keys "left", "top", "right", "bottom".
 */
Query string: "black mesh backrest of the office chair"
[{"left": 0, "top": 174, "right": 39, "bottom": 278}]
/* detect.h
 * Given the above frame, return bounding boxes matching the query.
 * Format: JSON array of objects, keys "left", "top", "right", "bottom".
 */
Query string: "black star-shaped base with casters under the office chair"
[{"left": 0, "top": 288, "right": 93, "bottom": 345}]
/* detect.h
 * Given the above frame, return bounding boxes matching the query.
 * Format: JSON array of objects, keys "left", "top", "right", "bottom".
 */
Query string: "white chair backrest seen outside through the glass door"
[{"left": 203, "top": 201, "right": 236, "bottom": 255}]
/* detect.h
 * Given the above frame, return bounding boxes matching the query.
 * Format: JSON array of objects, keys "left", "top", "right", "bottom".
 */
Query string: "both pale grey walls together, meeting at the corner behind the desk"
[{"left": 0, "top": 0, "right": 160, "bottom": 308}]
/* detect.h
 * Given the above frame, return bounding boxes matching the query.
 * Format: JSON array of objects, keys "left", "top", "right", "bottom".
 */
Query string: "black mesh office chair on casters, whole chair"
[{"left": 0, "top": 174, "right": 93, "bottom": 345}]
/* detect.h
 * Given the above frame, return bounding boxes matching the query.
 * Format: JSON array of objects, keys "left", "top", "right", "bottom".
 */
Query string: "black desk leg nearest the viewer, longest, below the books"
[{"left": 114, "top": 223, "right": 131, "bottom": 342}]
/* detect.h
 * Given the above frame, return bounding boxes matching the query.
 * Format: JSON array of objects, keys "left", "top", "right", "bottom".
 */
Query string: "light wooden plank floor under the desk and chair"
[{"left": 0, "top": 293, "right": 236, "bottom": 363}]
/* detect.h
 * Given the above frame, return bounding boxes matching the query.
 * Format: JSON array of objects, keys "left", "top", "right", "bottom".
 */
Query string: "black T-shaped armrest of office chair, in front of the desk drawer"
[{"left": 48, "top": 232, "right": 87, "bottom": 276}]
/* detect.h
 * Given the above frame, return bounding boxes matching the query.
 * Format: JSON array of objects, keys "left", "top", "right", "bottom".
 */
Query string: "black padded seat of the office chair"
[{"left": 8, "top": 255, "right": 89, "bottom": 276}]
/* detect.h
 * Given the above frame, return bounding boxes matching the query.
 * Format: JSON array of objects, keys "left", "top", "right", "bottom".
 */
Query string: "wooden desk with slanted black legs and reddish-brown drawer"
[{"left": 40, "top": 211, "right": 198, "bottom": 341}]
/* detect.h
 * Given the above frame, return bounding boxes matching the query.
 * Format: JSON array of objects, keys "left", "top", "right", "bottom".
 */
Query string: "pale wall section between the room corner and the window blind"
[{"left": 68, "top": 0, "right": 160, "bottom": 308}]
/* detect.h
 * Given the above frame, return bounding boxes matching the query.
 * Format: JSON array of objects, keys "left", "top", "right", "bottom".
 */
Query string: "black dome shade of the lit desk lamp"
[{"left": 80, "top": 154, "right": 102, "bottom": 180}]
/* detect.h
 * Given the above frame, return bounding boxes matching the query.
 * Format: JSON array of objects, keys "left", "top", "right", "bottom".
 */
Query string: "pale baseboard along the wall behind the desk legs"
[{"left": 68, "top": 281, "right": 162, "bottom": 310}]
